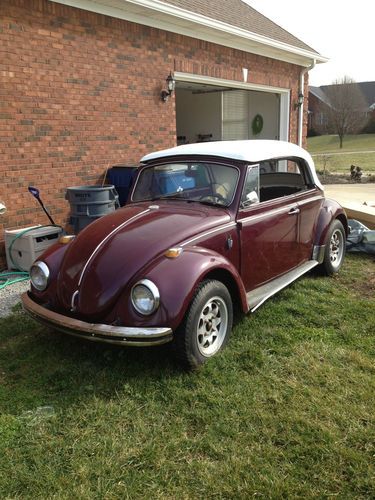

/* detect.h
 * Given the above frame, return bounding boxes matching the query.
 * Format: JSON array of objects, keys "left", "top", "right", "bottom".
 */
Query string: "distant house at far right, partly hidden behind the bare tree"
[{"left": 308, "top": 82, "right": 375, "bottom": 135}]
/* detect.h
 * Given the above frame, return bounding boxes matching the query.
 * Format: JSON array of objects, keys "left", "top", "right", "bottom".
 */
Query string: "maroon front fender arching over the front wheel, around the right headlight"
[{"left": 115, "top": 247, "right": 248, "bottom": 330}]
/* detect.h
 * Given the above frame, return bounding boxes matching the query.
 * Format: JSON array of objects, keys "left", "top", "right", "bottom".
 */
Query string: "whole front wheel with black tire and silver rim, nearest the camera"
[{"left": 174, "top": 280, "right": 233, "bottom": 370}]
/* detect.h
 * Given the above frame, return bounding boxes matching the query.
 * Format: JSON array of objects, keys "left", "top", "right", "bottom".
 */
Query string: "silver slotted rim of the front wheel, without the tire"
[{"left": 197, "top": 297, "right": 228, "bottom": 357}]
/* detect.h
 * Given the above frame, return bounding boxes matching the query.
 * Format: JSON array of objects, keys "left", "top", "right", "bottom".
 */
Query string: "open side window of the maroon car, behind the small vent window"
[{"left": 259, "top": 158, "right": 311, "bottom": 202}]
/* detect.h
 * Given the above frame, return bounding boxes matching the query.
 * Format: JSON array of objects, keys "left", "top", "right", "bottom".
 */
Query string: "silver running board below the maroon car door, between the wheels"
[{"left": 246, "top": 260, "right": 319, "bottom": 312}]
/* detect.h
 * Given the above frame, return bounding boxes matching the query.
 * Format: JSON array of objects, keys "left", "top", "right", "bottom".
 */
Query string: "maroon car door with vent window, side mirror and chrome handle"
[{"left": 237, "top": 165, "right": 300, "bottom": 291}]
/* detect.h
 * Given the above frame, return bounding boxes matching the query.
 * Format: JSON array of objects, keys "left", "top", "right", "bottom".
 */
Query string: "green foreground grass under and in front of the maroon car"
[{"left": 0, "top": 255, "right": 375, "bottom": 499}]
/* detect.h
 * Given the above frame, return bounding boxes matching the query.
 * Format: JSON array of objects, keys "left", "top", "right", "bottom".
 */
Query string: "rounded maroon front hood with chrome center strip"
[{"left": 57, "top": 201, "right": 230, "bottom": 317}]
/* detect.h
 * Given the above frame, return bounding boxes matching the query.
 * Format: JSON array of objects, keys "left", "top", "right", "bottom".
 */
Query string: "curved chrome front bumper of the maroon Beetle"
[{"left": 21, "top": 292, "right": 173, "bottom": 346}]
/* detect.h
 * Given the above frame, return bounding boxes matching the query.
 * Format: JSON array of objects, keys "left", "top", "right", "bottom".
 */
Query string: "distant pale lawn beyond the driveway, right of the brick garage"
[{"left": 307, "top": 134, "right": 375, "bottom": 176}]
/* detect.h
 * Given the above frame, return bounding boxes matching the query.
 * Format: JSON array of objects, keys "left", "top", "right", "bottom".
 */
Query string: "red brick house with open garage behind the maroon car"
[{"left": 0, "top": 0, "right": 326, "bottom": 268}]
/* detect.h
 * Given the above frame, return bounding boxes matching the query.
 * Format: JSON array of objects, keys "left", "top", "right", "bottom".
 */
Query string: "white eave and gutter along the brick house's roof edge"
[{"left": 51, "top": 0, "right": 328, "bottom": 66}]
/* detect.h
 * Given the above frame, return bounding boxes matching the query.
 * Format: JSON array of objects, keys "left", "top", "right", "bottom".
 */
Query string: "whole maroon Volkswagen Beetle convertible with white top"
[{"left": 22, "top": 141, "right": 348, "bottom": 368}]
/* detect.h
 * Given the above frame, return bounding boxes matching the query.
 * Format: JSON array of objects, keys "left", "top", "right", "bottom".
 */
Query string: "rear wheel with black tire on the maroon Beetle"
[{"left": 319, "top": 219, "right": 346, "bottom": 276}]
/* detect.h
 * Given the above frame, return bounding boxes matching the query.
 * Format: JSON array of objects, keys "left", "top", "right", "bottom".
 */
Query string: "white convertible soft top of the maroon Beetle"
[{"left": 141, "top": 140, "right": 324, "bottom": 189}]
